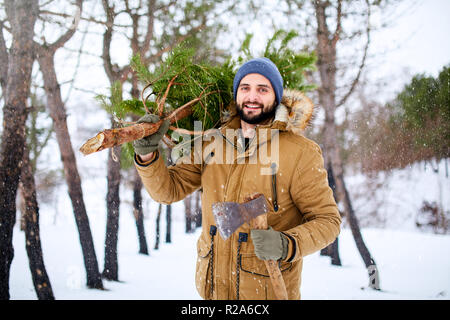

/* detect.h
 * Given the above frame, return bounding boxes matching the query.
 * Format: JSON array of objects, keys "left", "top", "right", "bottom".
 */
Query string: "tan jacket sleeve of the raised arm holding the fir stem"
[{"left": 135, "top": 152, "right": 201, "bottom": 204}]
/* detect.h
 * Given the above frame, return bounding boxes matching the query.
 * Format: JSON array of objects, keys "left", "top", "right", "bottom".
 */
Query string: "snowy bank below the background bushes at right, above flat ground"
[{"left": 346, "top": 161, "right": 450, "bottom": 231}]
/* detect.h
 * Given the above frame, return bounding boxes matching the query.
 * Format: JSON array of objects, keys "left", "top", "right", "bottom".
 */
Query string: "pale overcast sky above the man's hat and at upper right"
[{"left": 222, "top": 0, "right": 450, "bottom": 101}]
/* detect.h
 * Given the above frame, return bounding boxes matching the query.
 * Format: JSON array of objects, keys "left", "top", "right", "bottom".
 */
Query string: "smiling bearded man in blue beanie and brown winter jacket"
[{"left": 134, "top": 58, "right": 341, "bottom": 300}]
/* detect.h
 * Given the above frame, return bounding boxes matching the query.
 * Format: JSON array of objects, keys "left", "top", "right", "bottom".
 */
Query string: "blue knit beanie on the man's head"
[{"left": 233, "top": 58, "right": 283, "bottom": 105}]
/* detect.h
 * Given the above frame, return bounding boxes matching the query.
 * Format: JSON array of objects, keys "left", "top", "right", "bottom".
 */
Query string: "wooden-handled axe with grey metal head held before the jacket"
[{"left": 212, "top": 194, "right": 287, "bottom": 300}]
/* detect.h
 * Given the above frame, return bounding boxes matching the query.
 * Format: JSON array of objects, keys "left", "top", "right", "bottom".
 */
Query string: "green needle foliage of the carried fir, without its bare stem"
[{"left": 100, "top": 30, "right": 316, "bottom": 139}]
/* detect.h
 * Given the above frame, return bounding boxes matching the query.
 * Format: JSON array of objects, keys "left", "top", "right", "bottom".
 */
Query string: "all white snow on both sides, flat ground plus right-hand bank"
[{"left": 10, "top": 158, "right": 450, "bottom": 300}]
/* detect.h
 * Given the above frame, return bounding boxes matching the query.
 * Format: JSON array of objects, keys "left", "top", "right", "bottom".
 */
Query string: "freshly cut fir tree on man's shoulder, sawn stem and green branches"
[{"left": 80, "top": 30, "right": 316, "bottom": 155}]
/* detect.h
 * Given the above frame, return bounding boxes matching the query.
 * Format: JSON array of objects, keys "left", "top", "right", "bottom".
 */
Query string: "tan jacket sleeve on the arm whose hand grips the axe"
[{"left": 283, "top": 144, "right": 341, "bottom": 261}]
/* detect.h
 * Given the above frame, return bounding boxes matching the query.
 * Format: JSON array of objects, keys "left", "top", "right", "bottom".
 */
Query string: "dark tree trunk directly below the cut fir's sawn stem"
[{"left": 102, "top": 146, "right": 121, "bottom": 281}]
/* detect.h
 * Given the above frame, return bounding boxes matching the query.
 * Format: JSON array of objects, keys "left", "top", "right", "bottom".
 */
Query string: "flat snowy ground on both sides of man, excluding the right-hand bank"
[{"left": 10, "top": 200, "right": 450, "bottom": 300}]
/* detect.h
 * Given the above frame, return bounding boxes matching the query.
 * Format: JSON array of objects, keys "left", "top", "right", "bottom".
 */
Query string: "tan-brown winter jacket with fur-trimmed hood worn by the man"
[{"left": 136, "top": 90, "right": 341, "bottom": 300}]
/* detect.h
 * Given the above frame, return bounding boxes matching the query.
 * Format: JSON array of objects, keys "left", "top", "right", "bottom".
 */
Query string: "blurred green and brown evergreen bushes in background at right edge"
[{"left": 351, "top": 66, "right": 450, "bottom": 172}]
